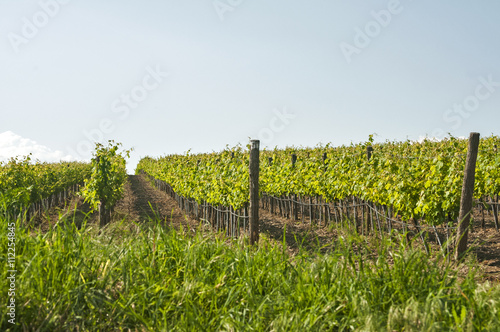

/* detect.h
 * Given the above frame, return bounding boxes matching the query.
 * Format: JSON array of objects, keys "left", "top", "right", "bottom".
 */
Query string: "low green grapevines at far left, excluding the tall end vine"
[{"left": 0, "top": 157, "right": 90, "bottom": 218}]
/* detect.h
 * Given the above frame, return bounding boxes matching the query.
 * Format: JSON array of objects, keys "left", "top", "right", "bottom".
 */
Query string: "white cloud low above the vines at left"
[{"left": 0, "top": 131, "right": 76, "bottom": 162}]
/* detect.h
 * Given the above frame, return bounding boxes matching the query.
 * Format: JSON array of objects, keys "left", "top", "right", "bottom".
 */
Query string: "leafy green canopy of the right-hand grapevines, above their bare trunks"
[{"left": 137, "top": 136, "right": 500, "bottom": 225}]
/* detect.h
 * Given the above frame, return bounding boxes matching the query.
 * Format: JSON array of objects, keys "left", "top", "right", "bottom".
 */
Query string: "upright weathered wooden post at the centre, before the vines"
[{"left": 249, "top": 140, "right": 260, "bottom": 245}]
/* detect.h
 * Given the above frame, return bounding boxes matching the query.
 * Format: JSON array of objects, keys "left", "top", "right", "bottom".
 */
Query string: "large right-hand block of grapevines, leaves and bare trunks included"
[{"left": 137, "top": 136, "right": 500, "bottom": 250}]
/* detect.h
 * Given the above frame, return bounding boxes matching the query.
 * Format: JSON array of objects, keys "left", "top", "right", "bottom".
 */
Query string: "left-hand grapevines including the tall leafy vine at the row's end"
[{"left": 0, "top": 141, "right": 130, "bottom": 225}]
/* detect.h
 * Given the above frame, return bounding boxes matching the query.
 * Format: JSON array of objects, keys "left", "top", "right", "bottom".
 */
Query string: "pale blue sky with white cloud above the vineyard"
[{"left": 0, "top": 0, "right": 500, "bottom": 173}]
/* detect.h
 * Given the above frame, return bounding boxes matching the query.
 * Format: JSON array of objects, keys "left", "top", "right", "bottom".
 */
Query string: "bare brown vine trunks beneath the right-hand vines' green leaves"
[{"left": 144, "top": 172, "right": 500, "bottom": 253}]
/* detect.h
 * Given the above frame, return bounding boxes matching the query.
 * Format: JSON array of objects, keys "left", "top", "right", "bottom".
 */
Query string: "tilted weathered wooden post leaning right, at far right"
[{"left": 455, "top": 133, "right": 479, "bottom": 260}]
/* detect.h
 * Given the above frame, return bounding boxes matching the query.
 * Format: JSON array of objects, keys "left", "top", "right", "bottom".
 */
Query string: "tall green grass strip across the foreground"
[{"left": 0, "top": 215, "right": 500, "bottom": 331}]
